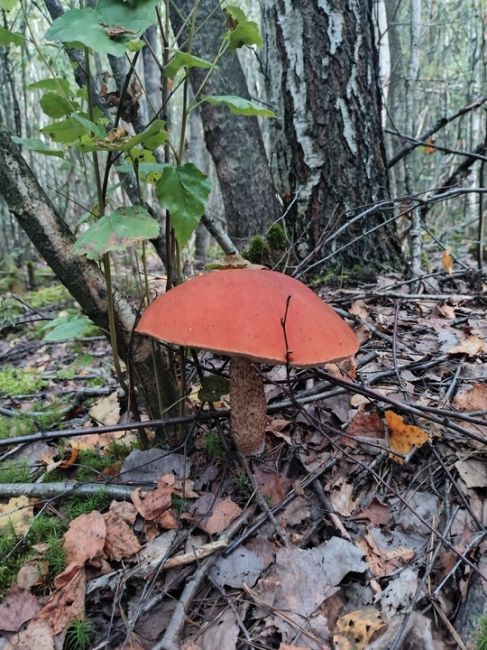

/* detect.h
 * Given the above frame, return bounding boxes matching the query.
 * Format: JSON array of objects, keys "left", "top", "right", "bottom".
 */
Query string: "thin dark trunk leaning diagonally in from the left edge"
[{"left": 0, "top": 125, "right": 177, "bottom": 418}]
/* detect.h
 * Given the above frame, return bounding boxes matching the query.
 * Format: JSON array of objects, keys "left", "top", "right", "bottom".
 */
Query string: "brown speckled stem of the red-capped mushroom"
[{"left": 230, "top": 357, "right": 267, "bottom": 455}]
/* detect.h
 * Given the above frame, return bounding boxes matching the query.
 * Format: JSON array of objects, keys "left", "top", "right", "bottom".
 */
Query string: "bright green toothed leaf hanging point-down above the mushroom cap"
[{"left": 156, "top": 163, "right": 211, "bottom": 248}]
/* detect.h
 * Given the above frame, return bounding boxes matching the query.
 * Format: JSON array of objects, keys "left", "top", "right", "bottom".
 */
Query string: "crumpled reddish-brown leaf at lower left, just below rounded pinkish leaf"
[{"left": 35, "top": 563, "right": 86, "bottom": 632}]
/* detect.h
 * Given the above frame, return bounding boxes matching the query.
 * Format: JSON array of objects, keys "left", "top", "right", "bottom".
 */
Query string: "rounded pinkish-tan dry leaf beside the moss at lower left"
[{"left": 64, "top": 510, "right": 107, "bottom": 565}]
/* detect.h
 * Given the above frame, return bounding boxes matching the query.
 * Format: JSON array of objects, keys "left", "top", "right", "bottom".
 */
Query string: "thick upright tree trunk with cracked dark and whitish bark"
[{"left": 264, "top": 0, "right": 399, "bottom": 266}]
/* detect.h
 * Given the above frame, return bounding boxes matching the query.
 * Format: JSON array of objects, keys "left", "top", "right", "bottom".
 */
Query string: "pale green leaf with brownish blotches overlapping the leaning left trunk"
[{"left": 72, "top": 205, "right": 159, "bottom": 260}]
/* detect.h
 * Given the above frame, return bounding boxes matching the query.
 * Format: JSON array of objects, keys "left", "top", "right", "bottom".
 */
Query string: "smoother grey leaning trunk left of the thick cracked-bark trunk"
[{"left": 171, "top": 0, "right": 280, "bottom": 245}]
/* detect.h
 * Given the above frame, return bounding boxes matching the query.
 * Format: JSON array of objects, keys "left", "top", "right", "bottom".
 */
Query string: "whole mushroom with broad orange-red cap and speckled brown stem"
[{"left": 136, "top": 268, "right": 359, "bottom": 454}]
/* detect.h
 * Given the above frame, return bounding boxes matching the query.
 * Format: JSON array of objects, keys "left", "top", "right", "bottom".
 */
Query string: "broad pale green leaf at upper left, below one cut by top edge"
[{"left": 45, "top": 7, "right": 129, "bottom": 56}]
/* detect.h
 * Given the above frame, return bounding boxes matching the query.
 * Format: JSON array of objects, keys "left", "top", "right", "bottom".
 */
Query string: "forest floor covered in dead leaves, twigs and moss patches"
[{"left": 0, "top": 258, "right": 487, "bottom": 650}]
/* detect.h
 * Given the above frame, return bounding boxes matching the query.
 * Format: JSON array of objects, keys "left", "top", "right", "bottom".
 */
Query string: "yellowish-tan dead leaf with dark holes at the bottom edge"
[{"left": 333, "top": 607, "right": 386, "bottom": 650}]
